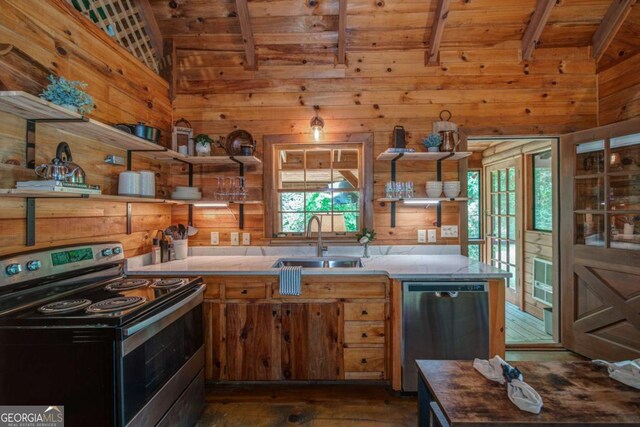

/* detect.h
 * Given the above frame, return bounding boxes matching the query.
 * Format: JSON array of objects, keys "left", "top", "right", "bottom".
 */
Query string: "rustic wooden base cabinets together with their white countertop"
[{"left": 128, "top": 255, "right": 509, "bottom": 390}]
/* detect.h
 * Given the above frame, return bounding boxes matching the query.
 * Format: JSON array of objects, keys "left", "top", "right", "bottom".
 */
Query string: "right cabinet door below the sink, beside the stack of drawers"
[{"left": 280, "top": 302, "right": 344, "bottom": 380}]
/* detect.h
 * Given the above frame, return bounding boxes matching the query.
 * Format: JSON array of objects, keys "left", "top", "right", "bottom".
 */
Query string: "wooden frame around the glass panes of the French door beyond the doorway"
[{"left": 482, "top": 156, "right": 524, "bottom": 310}]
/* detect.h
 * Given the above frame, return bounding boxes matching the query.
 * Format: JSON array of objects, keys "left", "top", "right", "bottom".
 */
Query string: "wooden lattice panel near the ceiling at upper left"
[{"left": 67, "top": 0, "right": 159, "bottom": 73}]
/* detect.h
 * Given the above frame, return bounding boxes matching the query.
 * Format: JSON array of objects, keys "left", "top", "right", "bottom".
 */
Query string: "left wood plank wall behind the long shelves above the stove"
[{"left": 0, "top": 0, "right": 171, "bottom": 256}]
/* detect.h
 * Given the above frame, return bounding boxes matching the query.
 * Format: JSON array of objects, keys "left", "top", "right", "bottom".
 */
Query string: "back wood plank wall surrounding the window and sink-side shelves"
[{"left": 174, "top": 44, "right": 597, "bottom": 245}]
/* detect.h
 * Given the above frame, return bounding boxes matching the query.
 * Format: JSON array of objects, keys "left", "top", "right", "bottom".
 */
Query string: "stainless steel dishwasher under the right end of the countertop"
[{"left": 402, "top": 282, "right": 489, "bottom": 391}]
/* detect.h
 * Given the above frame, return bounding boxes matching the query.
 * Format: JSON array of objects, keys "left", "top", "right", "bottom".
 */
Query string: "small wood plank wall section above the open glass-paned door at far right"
[{"left": 598, "top": 54, "right": 640, "bottom": 126}]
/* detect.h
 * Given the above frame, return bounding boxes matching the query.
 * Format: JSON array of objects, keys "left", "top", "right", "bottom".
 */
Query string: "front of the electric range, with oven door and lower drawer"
[{"left": 118, "top": 285, "right": 205, "bottom": 426}]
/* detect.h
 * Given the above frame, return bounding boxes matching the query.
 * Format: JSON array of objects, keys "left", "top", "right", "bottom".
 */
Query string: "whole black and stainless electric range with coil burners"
[{"left": 0, "top": 243, "right": 204, "bottom": 426}]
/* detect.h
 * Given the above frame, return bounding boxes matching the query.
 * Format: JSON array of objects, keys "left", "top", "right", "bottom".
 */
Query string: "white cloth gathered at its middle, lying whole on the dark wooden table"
[{"left": 473, "top": 356, "right": 542, "bottom": 414}]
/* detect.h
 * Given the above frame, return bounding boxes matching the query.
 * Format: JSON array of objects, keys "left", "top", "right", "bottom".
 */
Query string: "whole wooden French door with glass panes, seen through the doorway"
[{"left": 485, "top": 159, "right": 523, "bottom": 309}]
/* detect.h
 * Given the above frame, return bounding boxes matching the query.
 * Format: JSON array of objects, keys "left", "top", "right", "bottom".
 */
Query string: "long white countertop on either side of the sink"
[{"left": 127, "top": 255, "right": 510, "bottom": 280}]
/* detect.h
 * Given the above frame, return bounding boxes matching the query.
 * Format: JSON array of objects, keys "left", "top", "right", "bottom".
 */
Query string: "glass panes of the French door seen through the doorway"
[{"left": 487, "top": 162, "right": 518, "bottom": 293}]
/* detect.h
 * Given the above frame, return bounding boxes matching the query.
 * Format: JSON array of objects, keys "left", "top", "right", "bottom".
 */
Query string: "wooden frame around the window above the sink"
[{"left": 263, "top": 133, "right": 374, "bottom": 242}]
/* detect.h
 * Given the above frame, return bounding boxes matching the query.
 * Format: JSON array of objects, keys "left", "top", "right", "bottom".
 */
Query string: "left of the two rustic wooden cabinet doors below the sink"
[{"left": 225, "top": 304, "right": 280, "bottom": 381}]
